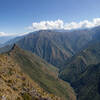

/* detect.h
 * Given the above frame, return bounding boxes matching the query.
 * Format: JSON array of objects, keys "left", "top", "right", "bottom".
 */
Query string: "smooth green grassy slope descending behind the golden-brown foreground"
[{"left": 9, "top": 46, "right": 75, "bottom": 100}]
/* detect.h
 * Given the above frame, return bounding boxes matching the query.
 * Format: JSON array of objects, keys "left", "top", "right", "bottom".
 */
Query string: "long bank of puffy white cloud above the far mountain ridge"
[{"left": 28, "top": 18, "right": 100, "bottom": 31}]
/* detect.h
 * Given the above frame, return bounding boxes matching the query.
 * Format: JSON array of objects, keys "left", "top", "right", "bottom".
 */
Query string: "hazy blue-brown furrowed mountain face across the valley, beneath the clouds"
[{"left": 11, "top": 30, "right": 92, "bottom": 68}]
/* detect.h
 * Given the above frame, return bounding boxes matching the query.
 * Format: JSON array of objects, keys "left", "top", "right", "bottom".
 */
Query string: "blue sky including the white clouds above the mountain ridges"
[{"left": 0, "top": 0, "right": 100, "bottom": 36}]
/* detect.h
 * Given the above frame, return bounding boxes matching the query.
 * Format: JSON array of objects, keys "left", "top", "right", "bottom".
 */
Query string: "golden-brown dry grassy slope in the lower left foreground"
[{"left": 0, "top": 54, "right": 60, "bottom": 100}]
